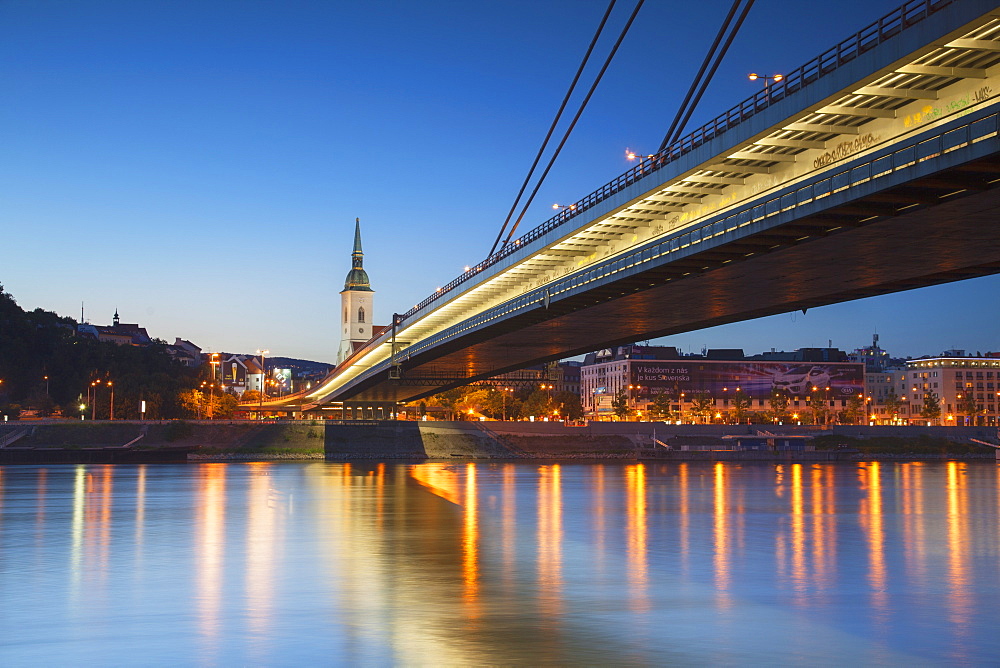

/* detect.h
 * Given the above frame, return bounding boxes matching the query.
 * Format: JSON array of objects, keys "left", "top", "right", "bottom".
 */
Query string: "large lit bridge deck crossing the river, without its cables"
[{"left": 263, "top": 0, "right": 1000, "bottom": 418}]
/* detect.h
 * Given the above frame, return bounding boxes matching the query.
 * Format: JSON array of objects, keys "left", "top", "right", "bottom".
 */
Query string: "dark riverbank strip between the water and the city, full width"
[{"left": 0, "top": 421, "right": 996, "bottom": 463}]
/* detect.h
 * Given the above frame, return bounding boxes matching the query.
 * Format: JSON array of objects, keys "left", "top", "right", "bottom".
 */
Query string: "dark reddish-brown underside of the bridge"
[{"left": 348, "top": 154, "right": 1000, "bottom": 401}]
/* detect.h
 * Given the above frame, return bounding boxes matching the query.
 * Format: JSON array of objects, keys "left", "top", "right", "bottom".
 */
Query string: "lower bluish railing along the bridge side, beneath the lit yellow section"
[{"left": 371, "top": 107, "right": 1000, "bottom": 384}]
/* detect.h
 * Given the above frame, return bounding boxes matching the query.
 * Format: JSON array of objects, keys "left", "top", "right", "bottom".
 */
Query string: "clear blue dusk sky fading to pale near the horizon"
[{"left": 0, "top": 0, "right": 1000, "bottom": 362}]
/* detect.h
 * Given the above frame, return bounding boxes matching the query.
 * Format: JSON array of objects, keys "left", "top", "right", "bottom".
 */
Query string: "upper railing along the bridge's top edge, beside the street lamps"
[{"left": 402, "top": 0, "right": 955, "bottom": 320}]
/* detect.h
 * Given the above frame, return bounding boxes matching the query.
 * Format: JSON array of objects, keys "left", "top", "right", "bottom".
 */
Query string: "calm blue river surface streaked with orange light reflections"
[{"left": 0, "top": 462, "right": 1000, "bottom": 666}]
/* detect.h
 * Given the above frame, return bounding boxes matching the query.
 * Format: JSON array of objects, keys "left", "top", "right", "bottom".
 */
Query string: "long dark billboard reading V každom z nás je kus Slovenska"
[{"left": 629, "top": 360, "right": 865, "bottom": 399}]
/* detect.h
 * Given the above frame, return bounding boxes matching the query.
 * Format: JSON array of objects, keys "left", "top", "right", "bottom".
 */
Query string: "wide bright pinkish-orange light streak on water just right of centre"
[{"left": 538, "top": 464, "right": 562, "bottom": 615}]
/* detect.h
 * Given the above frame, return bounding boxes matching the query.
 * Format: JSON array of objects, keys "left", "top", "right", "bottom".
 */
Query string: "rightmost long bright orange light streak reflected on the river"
[{"left": 947, "top": 462, "right": 972, "bottom": 639}]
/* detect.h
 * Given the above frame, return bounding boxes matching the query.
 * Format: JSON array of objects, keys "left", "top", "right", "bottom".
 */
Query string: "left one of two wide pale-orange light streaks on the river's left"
[{"left": 195, "top": 463, "right": 228, "bottom": 639}]
